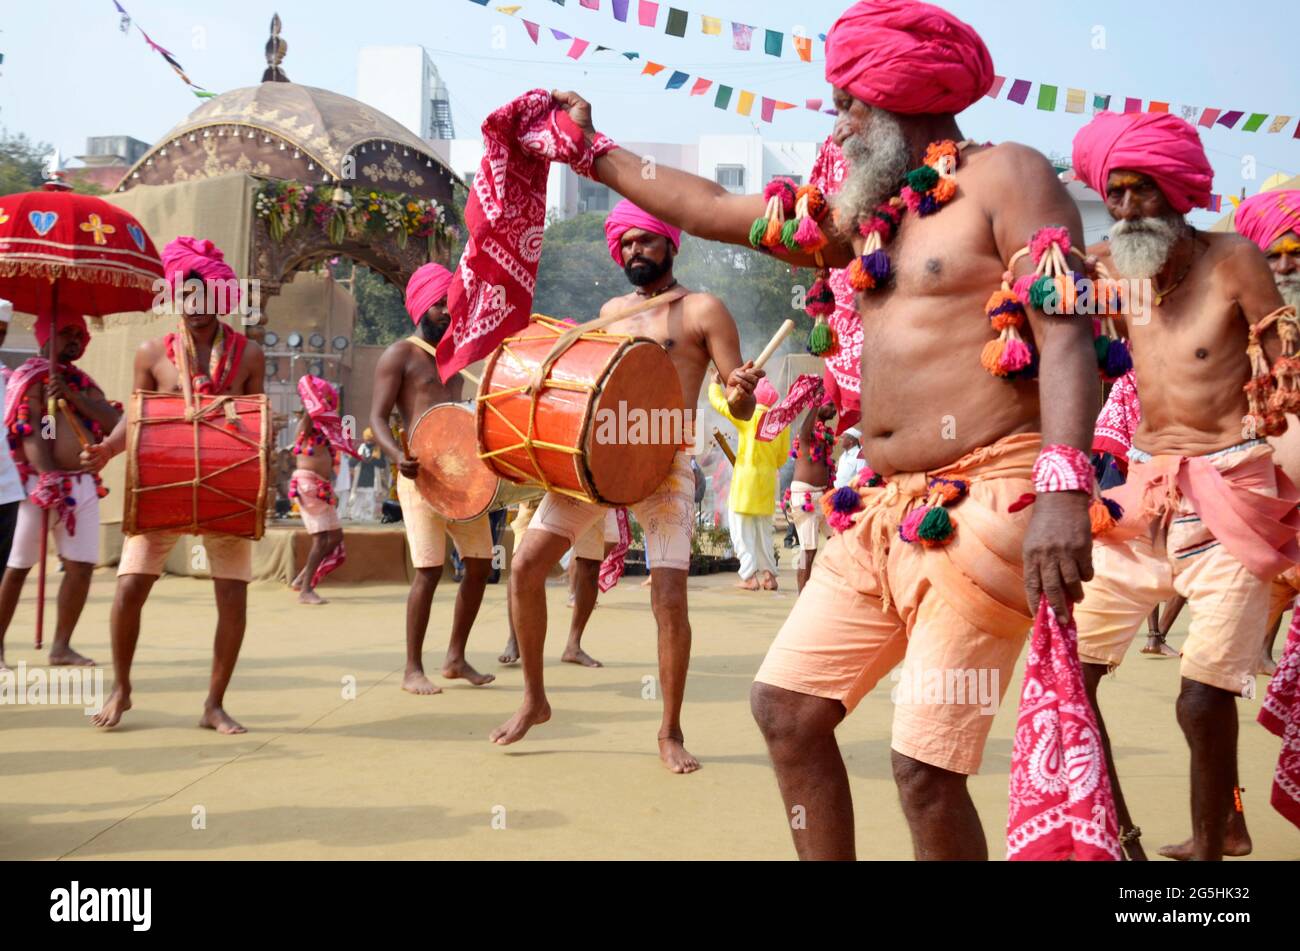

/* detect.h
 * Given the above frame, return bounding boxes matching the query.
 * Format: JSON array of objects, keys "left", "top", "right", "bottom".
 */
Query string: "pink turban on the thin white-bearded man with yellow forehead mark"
[{"left": 1074, "top": 112, "right": 1214, "bottom": 214}]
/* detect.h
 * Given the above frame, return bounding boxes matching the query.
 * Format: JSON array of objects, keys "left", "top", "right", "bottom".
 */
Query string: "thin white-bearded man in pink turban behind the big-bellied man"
[{"left": 1074, "top": 113, "right": 1300, "bottom": 860}]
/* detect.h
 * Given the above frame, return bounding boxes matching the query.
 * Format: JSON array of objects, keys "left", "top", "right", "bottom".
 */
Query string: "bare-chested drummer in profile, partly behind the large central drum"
[{"left": 371, "top": 262, "right": 497, "bottom": 696}]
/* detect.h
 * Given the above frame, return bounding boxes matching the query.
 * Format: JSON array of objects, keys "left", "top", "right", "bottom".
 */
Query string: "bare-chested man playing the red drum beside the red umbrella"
[{"left": 81, "top": 238, "right": 267, "bottom": 734}]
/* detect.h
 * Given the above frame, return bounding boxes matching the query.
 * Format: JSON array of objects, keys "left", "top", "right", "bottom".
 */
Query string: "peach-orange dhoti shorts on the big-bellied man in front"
[{"left": 755, "top": 433, "right": 1041, "bottom": 774}]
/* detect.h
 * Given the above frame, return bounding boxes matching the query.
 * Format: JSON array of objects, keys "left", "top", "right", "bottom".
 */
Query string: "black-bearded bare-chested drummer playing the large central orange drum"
[{"left": 491, "top": 200, "right": 759, "bottom": 773}]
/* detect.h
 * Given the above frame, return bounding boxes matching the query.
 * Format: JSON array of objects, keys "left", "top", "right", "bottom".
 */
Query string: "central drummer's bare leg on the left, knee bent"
[{"left": 490, "top": 529, "right": 572, "bottom": 746}]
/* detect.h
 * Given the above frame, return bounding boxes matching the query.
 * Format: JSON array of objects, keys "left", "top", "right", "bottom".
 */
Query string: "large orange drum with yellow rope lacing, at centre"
[{"left": 476, "top": 314, "right": 693, "bottom": 505}]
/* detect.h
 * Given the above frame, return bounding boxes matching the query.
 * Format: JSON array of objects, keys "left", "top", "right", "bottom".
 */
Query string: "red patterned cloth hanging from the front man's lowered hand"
[{"left": 1006, "top": 598, "right": 1121, "bottom": 861}]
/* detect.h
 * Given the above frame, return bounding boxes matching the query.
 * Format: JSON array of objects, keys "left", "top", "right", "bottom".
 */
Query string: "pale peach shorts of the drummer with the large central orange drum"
[{"left": 528, "top": 451, "right": 696, "bottom": 570}]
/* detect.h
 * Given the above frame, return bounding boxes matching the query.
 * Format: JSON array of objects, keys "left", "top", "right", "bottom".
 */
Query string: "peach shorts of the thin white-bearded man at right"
[{"left": 1074, "top": 472, "right": 1273, "bottom": 698}]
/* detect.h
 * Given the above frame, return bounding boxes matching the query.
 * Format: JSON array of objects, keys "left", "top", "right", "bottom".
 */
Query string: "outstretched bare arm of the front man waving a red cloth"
[{"left": 553, "top": 91, "right": 853, "bottom": 268}]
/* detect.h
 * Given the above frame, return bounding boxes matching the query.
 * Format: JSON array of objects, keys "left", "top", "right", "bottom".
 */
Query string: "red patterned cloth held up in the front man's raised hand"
[{"left": 438, "top": 90, "right": 615, "bottom": 382}]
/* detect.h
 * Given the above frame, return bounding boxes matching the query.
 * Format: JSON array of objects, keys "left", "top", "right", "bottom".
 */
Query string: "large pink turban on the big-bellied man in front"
[{"left": 826, "top": 0, "right": 993, "bottom": 116}]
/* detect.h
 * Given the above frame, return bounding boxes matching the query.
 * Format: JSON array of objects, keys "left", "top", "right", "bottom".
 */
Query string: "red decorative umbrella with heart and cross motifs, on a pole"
[{"left": 0, "top": 182, "right": 163, "bottom": 648}]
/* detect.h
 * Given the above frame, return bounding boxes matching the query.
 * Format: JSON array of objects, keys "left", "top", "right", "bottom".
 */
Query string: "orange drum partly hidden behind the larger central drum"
[{"left": 411, "top": 403, "right": 542, "bottom": 522}]
